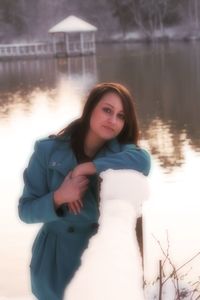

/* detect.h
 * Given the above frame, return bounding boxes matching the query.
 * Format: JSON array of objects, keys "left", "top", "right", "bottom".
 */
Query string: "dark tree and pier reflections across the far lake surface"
[{"left": 0, "top": 43, "right": 200, "bottom": 172}]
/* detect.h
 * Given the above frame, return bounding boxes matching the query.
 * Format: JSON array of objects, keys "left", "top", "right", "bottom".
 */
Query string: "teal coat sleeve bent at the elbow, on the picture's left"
[{"left": 18, "top": 142, "right": 59, "bottom": 223}]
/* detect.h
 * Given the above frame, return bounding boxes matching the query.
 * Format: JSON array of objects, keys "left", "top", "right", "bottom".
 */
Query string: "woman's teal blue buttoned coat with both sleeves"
[{"left": 18, "top": 137, "right": 150, "bottom": 300}]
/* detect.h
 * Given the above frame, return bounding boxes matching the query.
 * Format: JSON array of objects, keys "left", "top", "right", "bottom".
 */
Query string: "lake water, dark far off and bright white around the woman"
[{"left": 0, "top": 43, "right": 200, "bottom": 299}]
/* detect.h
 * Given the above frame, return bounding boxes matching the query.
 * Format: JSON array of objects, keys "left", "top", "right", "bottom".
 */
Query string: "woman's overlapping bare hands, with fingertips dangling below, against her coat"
[{"left": 54, "top": 172, "right": 89, "bottom": 213}]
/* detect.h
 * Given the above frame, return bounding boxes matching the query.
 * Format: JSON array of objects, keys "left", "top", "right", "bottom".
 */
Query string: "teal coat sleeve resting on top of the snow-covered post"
[{"left": 93, "top": 144, "right": 151, "bottom": 176}]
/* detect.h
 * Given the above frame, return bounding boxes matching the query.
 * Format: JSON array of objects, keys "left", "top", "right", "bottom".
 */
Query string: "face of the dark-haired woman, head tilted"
[{"left": 89, "top": 92, "right": 125, "bottom": 141}]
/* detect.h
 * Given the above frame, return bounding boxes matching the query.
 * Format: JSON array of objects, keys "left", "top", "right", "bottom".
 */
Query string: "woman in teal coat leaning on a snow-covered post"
[{"left": 19, "top": 83, "right": 150, "bottom": 300}]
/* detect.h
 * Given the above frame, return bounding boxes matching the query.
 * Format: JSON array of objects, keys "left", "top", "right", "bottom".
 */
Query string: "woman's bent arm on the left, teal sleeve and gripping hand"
[{"left": 18, "top": 142, "right": 89, "bottom": 223}]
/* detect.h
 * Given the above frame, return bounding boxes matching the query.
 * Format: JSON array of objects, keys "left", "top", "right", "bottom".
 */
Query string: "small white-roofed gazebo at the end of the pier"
[{"left": 49, "top": 16, "right": 97, "bottom": 56}]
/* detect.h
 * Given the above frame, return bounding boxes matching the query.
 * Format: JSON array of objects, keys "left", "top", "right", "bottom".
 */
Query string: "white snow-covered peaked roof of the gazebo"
[{"left": 49, "top": 16, "right": 97, "bottom": 33}]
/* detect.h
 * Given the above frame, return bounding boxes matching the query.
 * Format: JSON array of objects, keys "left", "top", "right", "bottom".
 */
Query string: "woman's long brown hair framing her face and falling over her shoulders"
[{"left": 56, "top": 82, "right": 139, "bottom": 161}]
